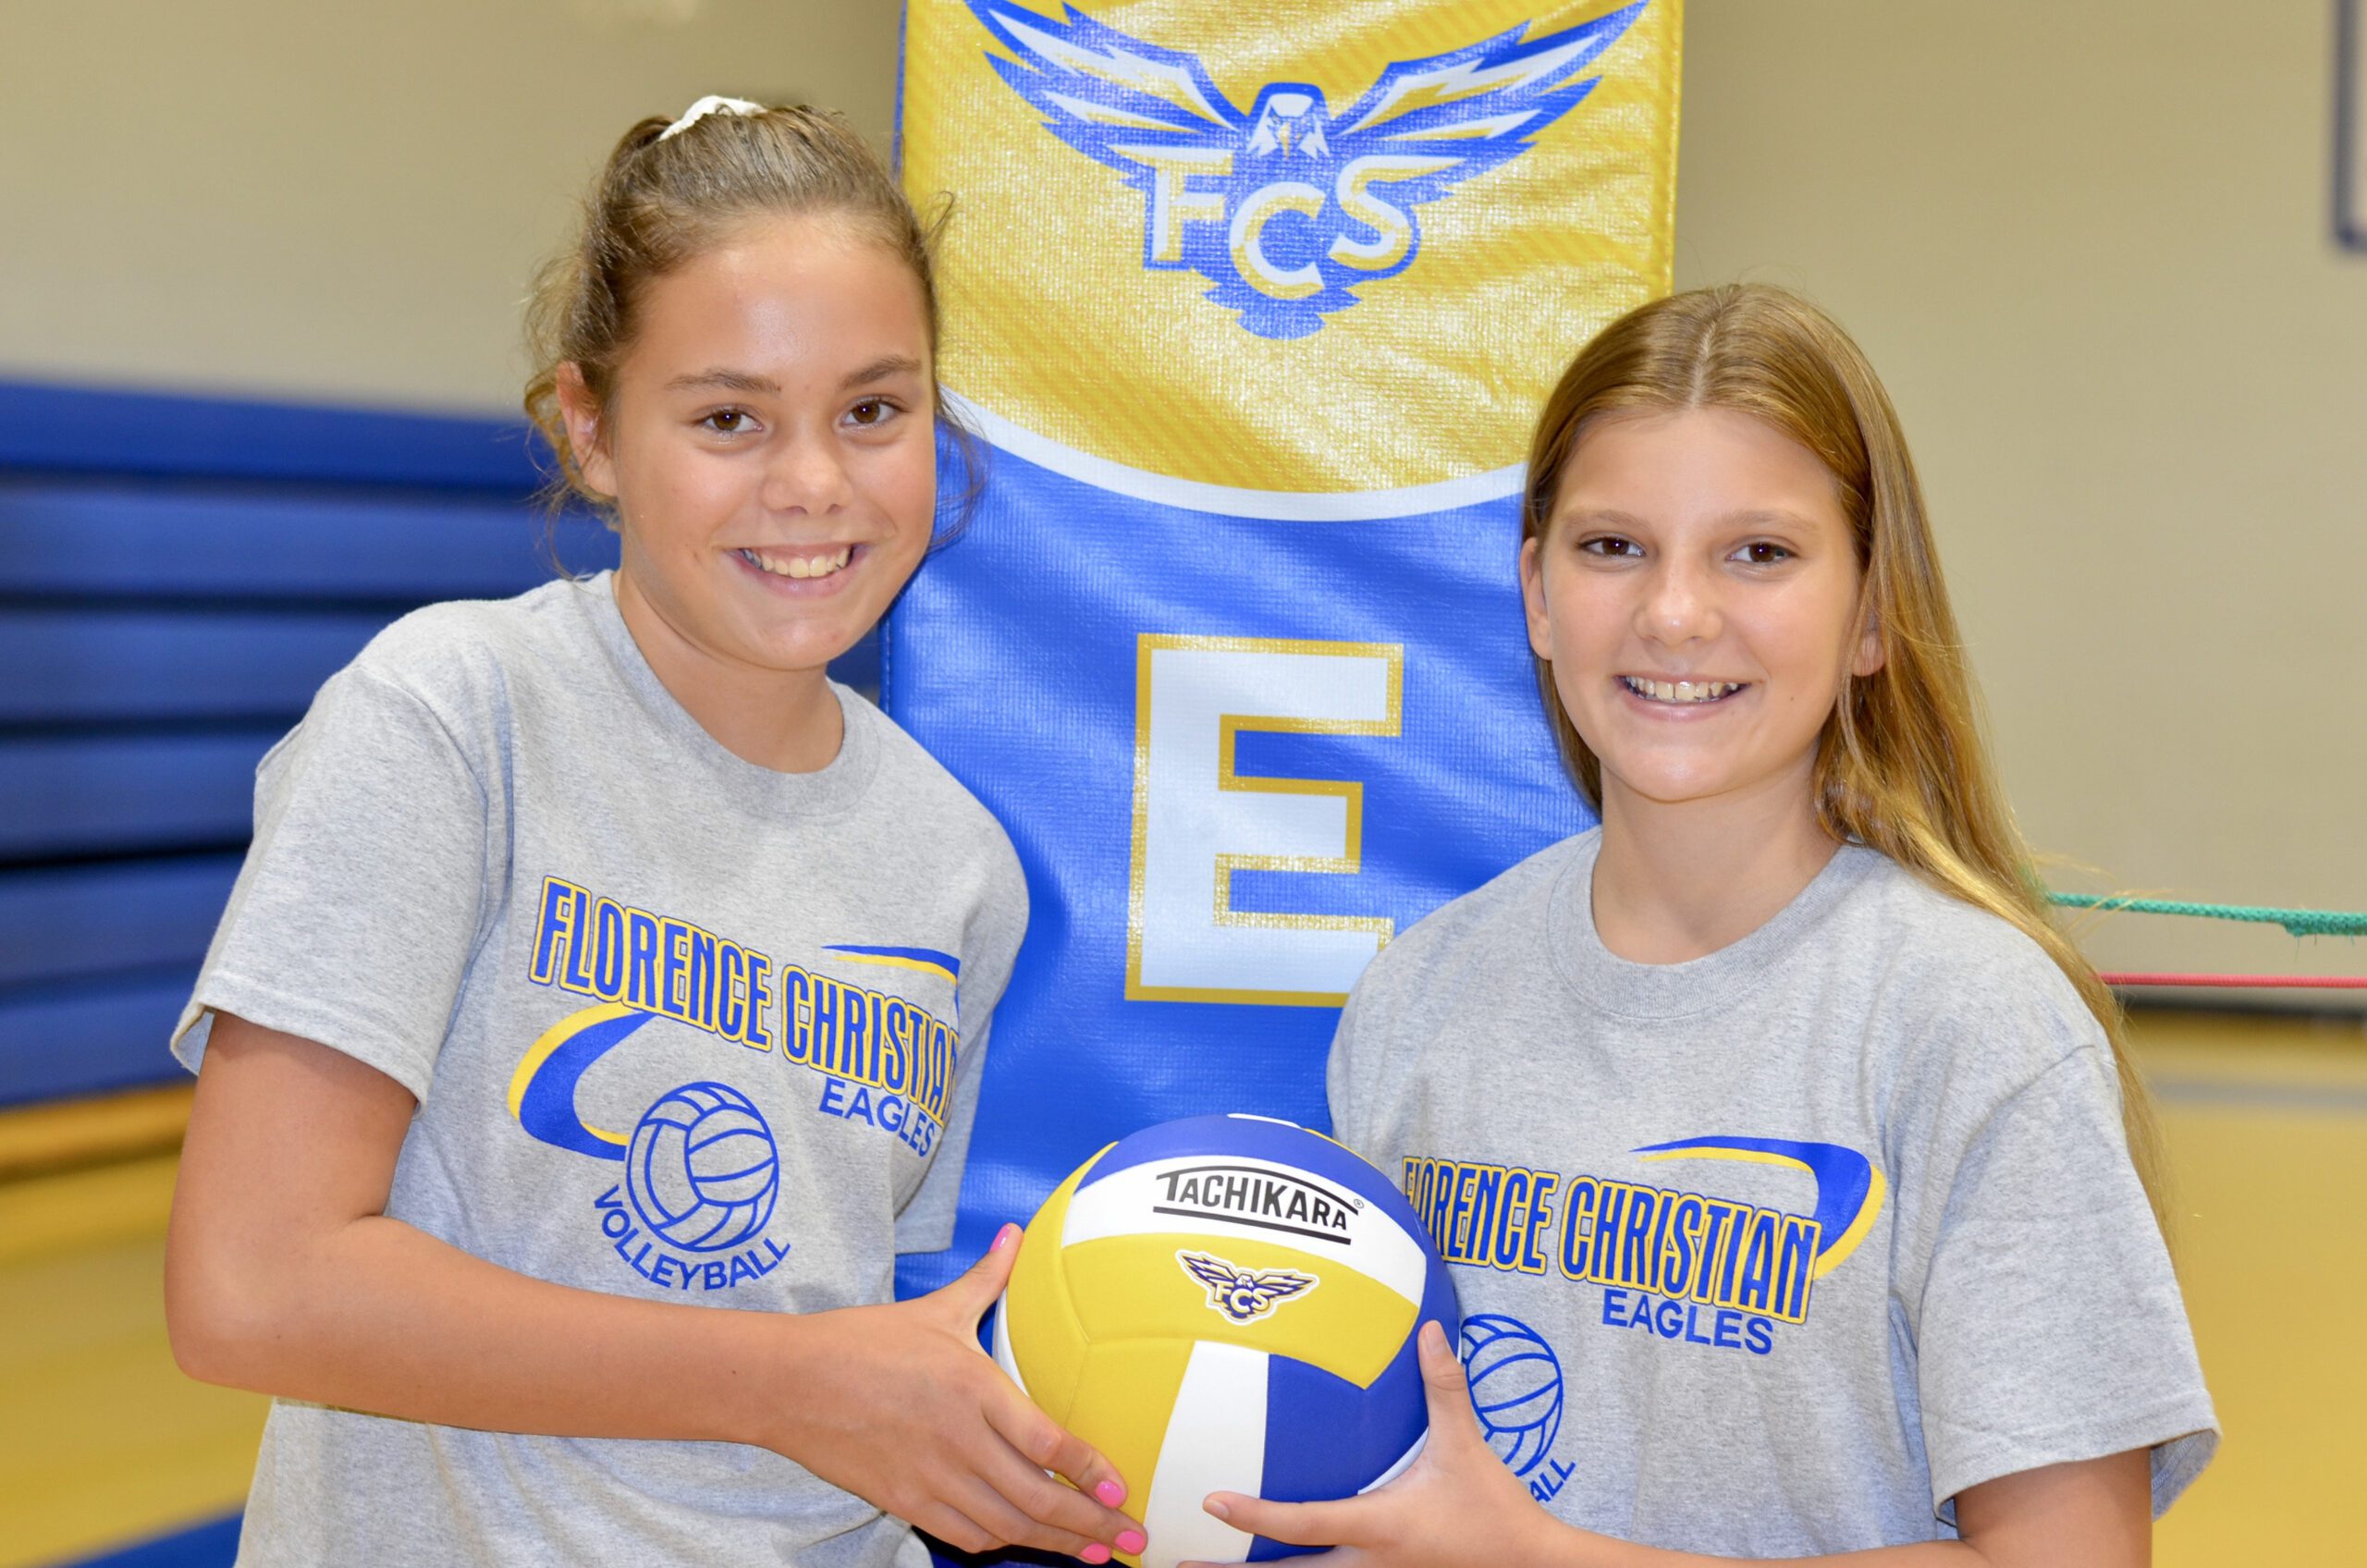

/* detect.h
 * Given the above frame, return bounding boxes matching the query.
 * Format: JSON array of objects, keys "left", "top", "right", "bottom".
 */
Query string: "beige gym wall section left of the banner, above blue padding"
[{"left": 0, "top": 0, "right": 900, "bottom": 410}]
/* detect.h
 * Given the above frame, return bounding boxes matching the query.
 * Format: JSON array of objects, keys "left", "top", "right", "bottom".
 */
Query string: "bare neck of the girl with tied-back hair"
[{"left": 613, "top": 569, "right": 845, "bottom": 772}]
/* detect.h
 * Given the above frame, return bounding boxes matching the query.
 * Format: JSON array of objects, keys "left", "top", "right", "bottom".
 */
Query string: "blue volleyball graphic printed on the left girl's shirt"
[{"left": 625, "top": 1083, "right": 781, "bottom": 1253}]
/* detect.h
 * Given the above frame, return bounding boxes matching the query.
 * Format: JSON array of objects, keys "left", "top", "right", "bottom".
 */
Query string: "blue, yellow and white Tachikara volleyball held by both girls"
[{"left": 994, "top": 1116, "right": 1455, "bottom": 1568}]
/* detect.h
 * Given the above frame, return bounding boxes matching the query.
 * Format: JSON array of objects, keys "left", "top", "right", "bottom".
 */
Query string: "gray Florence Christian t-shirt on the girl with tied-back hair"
[{"left": 175, "top": 576, "right": 1027, "bottom": 1568}]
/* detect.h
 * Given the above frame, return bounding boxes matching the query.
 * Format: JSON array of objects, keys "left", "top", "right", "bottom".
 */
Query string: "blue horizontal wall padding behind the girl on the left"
[{"left": 0, "top": 384, "right": 616, "bottom": 1113}]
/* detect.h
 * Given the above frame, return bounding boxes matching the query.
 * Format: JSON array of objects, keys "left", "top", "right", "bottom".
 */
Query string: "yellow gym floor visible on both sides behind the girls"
[{"left": 0, "top": 1011, "right": 2367, "bottom": 1568}]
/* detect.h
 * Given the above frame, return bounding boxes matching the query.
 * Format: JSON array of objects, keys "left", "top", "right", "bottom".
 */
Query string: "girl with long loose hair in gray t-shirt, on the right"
[{"left": 1208, "top": 287, "right": 2218, "bottom": 1568}]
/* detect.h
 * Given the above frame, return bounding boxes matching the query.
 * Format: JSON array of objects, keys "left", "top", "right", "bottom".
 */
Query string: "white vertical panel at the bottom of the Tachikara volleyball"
[{"left": 1135, "top": 1335, "right": 1267, "bottom": 1568}]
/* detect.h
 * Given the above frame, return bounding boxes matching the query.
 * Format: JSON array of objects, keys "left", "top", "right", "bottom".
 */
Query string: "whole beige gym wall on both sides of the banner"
[{"left": 0, "top": 0, "right": 2367, "bottom": 974}]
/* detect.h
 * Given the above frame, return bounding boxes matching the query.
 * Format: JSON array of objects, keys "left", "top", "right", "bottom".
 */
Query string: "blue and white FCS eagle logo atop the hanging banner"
[{"left": 965, "top": 0, "right": 1643, "bottom": 338}]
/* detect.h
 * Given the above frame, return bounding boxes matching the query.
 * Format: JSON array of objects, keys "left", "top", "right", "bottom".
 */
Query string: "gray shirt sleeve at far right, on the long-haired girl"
[{"left": 1910, "top": 1042, "right": 2218, "bottom": 1518}]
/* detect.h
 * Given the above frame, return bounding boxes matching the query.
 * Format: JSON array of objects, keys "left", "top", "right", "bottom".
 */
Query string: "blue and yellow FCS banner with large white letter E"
[{"left": 883, "top": 0, "right": 1681, "bottom": 1289}]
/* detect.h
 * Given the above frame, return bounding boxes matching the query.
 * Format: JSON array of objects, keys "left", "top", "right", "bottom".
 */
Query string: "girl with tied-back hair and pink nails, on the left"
[{"left": 166, "top": 100, "right": 1143, "bottom": 1568}]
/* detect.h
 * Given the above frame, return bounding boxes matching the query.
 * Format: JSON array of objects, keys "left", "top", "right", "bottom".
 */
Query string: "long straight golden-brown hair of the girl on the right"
[{"left": 1522, "top": 284, "right": 2168, "bottom": 1230}]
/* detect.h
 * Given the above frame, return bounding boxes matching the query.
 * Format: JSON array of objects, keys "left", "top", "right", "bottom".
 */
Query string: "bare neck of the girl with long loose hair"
[{"left": 1593, "top": 767, "right": 1842, "bottom": 964}]
